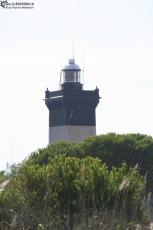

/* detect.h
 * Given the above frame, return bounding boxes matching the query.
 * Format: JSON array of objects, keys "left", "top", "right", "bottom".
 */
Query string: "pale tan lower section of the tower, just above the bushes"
[{"left": 49, "top": 125, "right": 96, "bottom": 143}]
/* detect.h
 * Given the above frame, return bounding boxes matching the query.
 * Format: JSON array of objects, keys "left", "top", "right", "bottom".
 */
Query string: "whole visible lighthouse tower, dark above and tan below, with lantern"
[{"left": 45, "top": 59, "right": 99, "bottom": 143}]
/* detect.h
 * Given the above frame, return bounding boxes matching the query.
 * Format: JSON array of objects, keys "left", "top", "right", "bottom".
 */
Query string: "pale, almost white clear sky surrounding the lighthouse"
[{"left": 0, "top": 0, "right": 153, "bottom": 169}]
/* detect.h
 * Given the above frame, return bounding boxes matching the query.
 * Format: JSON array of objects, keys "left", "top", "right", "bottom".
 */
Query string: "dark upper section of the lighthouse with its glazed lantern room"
[{"left": 45, "top": 59, "right": 99, "bottom": 142}]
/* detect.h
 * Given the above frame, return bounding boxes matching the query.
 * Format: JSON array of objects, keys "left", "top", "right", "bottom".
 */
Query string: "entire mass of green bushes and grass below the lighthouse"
[{"left": 0, "top": 134, "right": 153, "bottom": 230}]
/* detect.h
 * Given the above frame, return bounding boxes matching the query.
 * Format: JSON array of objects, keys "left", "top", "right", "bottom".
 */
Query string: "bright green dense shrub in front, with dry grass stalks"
[{"left": 0, "top": 155, "right": 144, "bottom": 230}]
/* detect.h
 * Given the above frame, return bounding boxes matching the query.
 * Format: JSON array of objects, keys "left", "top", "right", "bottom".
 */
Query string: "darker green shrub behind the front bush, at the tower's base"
[{"left": 29, "top": 133, "right": 153, "bottom": 192}]
